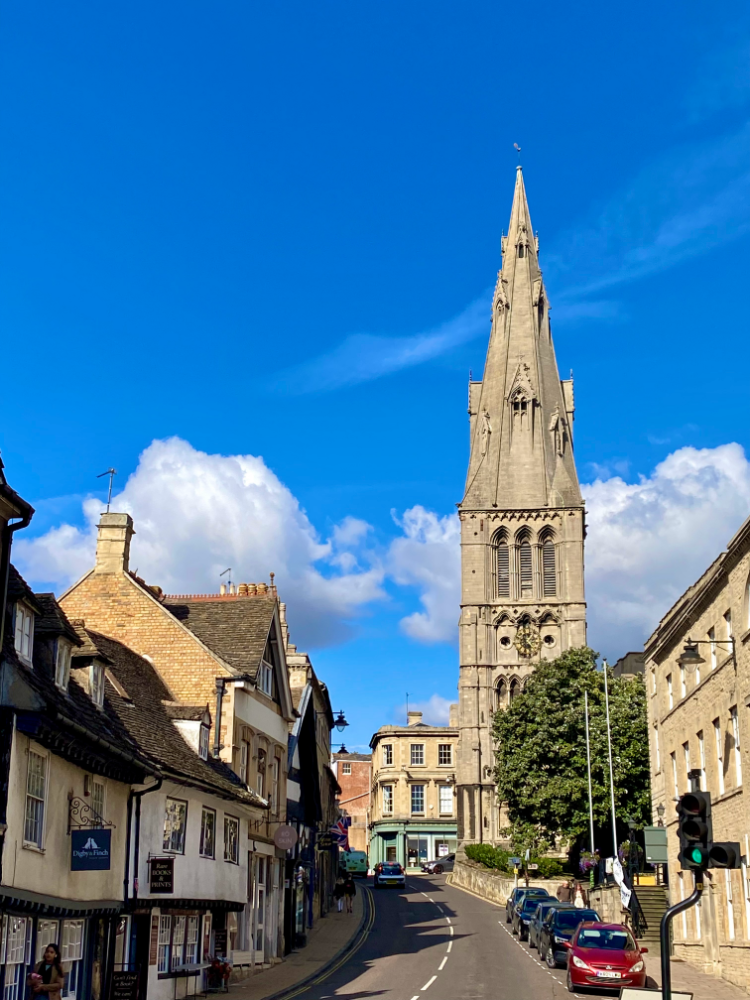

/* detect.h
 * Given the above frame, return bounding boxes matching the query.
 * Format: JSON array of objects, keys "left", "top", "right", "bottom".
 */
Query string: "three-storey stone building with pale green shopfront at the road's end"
[{"left": 370, "top": 712, "right": 458, "bottom": 868}]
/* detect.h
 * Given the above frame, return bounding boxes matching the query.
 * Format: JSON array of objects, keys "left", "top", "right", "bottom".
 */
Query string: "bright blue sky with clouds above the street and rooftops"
[{"left": 0, "top": 0, "right": 750, "bottom": 745}]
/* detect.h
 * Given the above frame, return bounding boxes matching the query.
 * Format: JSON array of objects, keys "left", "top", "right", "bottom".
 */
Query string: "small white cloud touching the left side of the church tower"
[{"left": 388, "top": 506, "right": 461, "bottom": 642}]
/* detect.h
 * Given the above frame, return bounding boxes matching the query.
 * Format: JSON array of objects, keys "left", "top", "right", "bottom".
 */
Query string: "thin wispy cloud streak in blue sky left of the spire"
[{"left": 273, "top": 290, "right": 491, "bottom": 395}]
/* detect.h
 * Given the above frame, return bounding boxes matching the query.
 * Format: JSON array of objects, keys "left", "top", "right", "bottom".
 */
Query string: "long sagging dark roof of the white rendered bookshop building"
[{"left": 78, "top": 629, "right": 267, "bottom": 808}]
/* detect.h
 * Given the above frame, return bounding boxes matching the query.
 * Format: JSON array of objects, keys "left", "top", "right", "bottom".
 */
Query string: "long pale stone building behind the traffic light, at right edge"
[{"left": 645, "top": 519, "right": 750, "bottom": 988}]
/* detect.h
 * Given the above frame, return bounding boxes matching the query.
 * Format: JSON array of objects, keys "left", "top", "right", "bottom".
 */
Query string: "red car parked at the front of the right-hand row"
[{"left": 565, "top": 923, "right": 648, "bottom": 993}]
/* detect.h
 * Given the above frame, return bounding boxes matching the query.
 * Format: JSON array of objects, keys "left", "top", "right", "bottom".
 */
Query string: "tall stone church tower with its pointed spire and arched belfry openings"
[{"left": 456, "top": 166, "right": 586, "bottom": 843}]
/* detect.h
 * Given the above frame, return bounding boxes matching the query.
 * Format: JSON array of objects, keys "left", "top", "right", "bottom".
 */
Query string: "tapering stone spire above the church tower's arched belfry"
[{"left": 461, "top": 166, "right": 582, "bottom": 510}]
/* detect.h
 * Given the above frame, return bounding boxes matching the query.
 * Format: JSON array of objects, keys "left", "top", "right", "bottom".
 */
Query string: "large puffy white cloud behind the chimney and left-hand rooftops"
[{"left": 13, "top": 438, "right": 385, "bottom": 645}]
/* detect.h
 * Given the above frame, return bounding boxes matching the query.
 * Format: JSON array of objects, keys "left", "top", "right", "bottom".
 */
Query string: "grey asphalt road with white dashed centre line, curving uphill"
[{"left": 300, "top": 875, "right": 644, "bottom": 1000}]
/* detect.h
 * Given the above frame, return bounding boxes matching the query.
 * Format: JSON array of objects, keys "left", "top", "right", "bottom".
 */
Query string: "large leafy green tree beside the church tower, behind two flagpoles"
[{"left": 494, "top": 647, "right": 651, "bottom": 854}]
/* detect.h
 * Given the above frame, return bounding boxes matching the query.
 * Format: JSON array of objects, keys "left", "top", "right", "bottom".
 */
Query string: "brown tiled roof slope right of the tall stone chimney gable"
[{"left": 163, "top": 595, "right": 276, "bottom": 677}]
